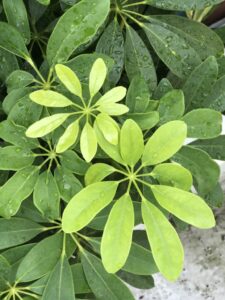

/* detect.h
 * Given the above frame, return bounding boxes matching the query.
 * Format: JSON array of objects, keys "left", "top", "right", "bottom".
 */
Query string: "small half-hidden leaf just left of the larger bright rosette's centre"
[{"left": 85, "top": 163, "right": 116, "bottom": 185}]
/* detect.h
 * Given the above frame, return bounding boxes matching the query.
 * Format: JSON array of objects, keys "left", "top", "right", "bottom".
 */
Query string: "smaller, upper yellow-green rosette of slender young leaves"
[{"left": 26, "top": 58, "right": 129, "bottom": 162}]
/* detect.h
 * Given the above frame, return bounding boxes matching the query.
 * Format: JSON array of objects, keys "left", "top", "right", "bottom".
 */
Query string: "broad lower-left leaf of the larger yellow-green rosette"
[{"left": 62, "top": 181, "right": 118, "bottom": 233}]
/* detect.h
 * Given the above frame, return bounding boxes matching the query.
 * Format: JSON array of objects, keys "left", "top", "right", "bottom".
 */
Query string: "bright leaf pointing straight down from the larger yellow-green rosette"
[{"left": 101, "top": 194, "right": 134, "bottom": 273}]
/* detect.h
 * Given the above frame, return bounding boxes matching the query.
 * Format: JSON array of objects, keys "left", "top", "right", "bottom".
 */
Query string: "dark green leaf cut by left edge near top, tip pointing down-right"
[{"left": 0, "top": 22, "right": 30, "bottom": 60}]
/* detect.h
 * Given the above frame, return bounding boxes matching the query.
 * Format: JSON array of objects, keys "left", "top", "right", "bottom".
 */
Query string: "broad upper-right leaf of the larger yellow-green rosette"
[{"left": 142, "top": 121, "right": 187, "bottom": 166}]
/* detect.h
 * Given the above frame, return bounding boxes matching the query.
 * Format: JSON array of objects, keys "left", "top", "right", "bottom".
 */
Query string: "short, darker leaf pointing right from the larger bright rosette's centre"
[{"left": 151, "top": 163, "right": 193, "bottom": 191}]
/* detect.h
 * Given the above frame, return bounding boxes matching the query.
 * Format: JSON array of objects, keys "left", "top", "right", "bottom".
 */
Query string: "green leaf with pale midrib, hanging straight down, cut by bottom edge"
[{"left": 42, "top": 256, "right": 75, "bottom": 300}]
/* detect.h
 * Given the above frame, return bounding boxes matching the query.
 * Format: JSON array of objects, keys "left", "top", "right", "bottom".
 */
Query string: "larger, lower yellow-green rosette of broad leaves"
[{"left": 62, "top": 119, "right": 215, "bottom": 281}]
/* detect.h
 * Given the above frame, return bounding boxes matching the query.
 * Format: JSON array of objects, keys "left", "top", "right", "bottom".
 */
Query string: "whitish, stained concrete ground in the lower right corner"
[{"left": 132, "top": 163, "right": 225, "bottom": 300}]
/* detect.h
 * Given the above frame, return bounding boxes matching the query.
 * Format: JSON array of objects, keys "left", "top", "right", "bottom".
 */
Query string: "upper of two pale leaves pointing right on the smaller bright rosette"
[{"left": 96, "top": 86, "right": 127, "bottom": 105}]
